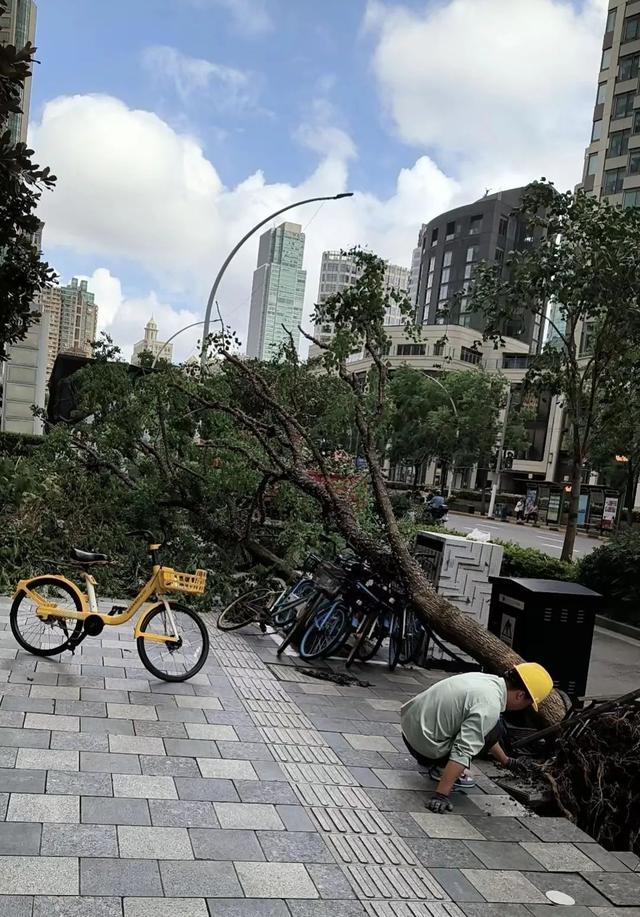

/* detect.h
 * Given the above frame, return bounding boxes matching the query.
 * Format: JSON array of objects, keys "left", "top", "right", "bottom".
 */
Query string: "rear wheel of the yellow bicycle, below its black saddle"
[{"left": 9, "top": 576, "right": 82, "bottom": 656}]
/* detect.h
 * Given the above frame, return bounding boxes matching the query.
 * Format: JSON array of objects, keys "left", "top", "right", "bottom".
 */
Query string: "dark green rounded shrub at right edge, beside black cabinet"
[{"left": 578, "top": 531, "right": 640, "bottom": 624}]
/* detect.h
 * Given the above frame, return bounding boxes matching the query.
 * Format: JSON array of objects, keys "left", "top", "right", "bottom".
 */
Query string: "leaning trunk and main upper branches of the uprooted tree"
[{"left": 190, "top": 250, "right": 564, "bottom": 722}]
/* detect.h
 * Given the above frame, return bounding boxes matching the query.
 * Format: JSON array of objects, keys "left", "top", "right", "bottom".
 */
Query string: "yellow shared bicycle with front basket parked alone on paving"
[{"left": 9, "top": 531, "right": 209, "bottom": 681}]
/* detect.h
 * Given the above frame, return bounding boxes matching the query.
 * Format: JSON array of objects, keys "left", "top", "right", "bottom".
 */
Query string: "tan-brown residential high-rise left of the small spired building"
[{"left": 35, "top": 277, "right": 98, "bottom": 375}]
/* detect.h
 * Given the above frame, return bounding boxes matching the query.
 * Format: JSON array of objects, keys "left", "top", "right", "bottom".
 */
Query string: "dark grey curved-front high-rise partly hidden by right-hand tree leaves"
[{"left": 416, "top": 188, "right": 541, "bottom": 351}]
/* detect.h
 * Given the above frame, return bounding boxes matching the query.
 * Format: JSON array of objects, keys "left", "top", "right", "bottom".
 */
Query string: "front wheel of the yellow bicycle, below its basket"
[{"left": 136, "top": 602, "right": 209, "bottom": 681}]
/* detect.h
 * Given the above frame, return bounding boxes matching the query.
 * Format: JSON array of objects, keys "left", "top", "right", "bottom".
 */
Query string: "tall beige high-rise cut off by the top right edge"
[{"left": 582, "top": 0, "right": 640, "bottom": 207}]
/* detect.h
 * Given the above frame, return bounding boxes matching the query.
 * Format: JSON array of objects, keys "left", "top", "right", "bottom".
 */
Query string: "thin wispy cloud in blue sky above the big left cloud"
[{"left": 142, "top": 45, "right": 258, "bottom": 112}]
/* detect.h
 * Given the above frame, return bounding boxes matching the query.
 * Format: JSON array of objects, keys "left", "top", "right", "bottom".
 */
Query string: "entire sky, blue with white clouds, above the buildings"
[{"left": 31, "top": 0, "right": 606, "bottom": 356}]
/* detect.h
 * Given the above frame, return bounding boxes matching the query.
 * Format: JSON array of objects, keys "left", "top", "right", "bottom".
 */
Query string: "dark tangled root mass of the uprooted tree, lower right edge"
[{"left": 545, "top": 703, "right": 640, "bottom": 854}]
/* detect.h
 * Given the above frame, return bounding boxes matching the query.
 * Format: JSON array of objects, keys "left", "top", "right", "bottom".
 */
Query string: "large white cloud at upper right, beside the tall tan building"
[{"left": 366, "top": 0, "right": 607, "bottom": 193}]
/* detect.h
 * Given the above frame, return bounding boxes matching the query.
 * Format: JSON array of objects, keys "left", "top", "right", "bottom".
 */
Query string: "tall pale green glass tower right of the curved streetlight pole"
[{"left": 247, "top": 223, "right": 307, "bottom": 360}]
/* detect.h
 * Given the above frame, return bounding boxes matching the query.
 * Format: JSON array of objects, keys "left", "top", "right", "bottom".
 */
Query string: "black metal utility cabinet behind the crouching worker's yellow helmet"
[{"left": 489, "top": 576, "right": 603, "bottom": 697}]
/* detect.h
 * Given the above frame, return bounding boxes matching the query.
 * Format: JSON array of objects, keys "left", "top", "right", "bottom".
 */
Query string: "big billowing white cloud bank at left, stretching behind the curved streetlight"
[{"left": 30, "top": 96, "right": 462, "bottom": 356}]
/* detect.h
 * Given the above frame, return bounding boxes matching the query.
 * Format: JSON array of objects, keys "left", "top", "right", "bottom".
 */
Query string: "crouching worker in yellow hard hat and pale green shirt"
[{"left": 400, "top": 662, "right": 553, "bottom": 813}]
